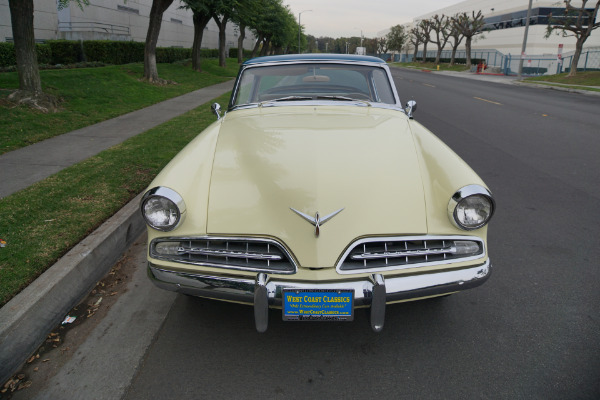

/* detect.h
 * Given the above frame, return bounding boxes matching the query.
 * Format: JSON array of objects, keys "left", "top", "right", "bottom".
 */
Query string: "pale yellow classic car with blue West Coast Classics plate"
[{"left": 140, "top": 54, "right": 495, "bottom": 332}]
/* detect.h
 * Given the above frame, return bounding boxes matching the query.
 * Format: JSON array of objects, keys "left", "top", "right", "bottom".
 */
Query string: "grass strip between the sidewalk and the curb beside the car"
[{"left": 0, "top": 94, "right": 230, "bottom": 306}]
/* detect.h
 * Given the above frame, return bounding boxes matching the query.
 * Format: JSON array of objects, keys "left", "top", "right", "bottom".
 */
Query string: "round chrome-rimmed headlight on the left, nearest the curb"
[{"left": 141, "top": 186, "right": 185, "bottom": 232}]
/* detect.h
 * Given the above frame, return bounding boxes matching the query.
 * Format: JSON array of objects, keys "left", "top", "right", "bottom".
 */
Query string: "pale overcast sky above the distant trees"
[{"left": 283, "top": 0, "right": 461, "bottom": 38}]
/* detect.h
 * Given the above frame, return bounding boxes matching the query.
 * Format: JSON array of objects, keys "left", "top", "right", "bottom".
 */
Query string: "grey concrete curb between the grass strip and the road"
[{"left": 0, "top": 194, "right": 145, "bottom": 384}]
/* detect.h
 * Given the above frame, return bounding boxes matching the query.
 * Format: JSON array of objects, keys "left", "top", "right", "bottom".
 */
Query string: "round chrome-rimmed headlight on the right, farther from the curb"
[{"left": 448, "top": 185, "right": 495, "bottom": 230}]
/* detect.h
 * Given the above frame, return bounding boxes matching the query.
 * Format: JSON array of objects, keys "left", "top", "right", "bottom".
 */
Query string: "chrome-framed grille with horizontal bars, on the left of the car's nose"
[{"left": 150, "top": 237, "right": 296, "bottom": 274}]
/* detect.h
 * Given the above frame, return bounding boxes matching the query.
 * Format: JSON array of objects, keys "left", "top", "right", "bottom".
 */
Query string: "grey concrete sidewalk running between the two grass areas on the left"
[{"left": 0, "top": 81, "right": 233, "bottom": 198}]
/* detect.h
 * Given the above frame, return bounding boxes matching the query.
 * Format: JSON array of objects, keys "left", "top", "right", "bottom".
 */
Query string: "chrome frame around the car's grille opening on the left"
[{"left": 148, "top": 236, "right": 298, "bottom": 275}]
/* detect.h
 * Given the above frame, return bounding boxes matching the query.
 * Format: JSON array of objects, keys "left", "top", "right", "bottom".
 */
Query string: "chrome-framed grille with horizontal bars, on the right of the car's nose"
[{"left": 338, "top": 236, "right": 485, "bottom": 272}]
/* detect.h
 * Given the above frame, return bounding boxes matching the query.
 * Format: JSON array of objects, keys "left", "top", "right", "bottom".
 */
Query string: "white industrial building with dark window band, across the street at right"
[{"left": 377, "top": 0, "right": 600, "bottom": 75}]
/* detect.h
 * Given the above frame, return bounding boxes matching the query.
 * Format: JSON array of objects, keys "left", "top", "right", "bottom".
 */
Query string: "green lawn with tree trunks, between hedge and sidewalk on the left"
[{"left": 0, "top": 59, "right": 239, "bottom": 154}]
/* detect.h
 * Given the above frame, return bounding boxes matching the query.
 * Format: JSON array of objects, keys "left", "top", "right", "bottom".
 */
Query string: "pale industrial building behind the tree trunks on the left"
[{"left": 0, "top": 0, "right": 255, "bottom": 49}]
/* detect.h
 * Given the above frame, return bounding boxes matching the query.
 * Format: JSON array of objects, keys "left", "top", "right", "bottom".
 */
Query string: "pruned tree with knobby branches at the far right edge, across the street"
[{"left": 544, "top": 0, "right": 600, "bottom": 76}]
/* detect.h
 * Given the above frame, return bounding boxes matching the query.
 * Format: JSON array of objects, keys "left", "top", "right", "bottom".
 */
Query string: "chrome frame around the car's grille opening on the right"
[{"left": 335, "top": 235, "right": 487, "bottom": 275}]
